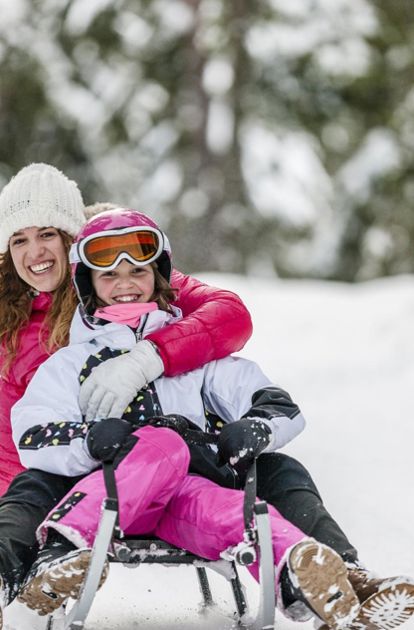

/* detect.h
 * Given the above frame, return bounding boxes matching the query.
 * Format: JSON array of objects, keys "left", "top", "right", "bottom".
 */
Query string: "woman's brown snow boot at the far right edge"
[{"left": 348, "top": 566, "right": 414, "bottom": 630}]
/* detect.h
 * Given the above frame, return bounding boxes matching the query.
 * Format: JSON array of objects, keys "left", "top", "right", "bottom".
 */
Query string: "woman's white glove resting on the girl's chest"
[{"left": 79, "top": 341, "right": 164, "bottom": 422}]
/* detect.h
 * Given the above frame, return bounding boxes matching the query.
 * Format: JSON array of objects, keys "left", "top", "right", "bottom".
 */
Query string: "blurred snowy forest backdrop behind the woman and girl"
[{"left": 0, "top": 0, "right": 414, "bottom": 280}]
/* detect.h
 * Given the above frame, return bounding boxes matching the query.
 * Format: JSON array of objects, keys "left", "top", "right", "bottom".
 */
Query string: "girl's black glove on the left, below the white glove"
[{"left": 86, "top": 418, "right": 134, "bottom": 462}]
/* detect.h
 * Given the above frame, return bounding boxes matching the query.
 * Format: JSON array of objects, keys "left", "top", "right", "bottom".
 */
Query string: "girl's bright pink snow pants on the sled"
[{"left": 38, "top": 426, "right": 305, "bottom": 579}]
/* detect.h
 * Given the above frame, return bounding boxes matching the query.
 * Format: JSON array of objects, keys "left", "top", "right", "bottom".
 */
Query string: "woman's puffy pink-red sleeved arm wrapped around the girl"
[{"left": 147, "top": 270, "right": 253, "bottom": 376}]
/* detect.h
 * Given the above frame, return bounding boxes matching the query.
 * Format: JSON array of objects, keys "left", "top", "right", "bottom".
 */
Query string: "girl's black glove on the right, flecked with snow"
[{"left": 217, "top": 418, "right": 272, "bottom": 473}]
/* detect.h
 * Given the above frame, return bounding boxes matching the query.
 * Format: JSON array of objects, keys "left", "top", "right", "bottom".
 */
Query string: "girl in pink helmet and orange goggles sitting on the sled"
[{"left": 12, "top": 209, "right": 359, "bottom": 628}]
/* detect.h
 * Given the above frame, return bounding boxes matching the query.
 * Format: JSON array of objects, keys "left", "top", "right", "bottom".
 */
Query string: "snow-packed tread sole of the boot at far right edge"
[{"left": 350, "top": 581, "right": 414, "bottom": 630}]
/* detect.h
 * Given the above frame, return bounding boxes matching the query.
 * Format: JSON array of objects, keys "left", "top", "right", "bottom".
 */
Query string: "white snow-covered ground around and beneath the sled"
[{"left": 5, "top": 275, "right": 414, "bottom": 630}]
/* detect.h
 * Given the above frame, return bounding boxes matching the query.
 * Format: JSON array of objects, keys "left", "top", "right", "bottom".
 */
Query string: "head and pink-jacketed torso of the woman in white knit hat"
[{"left": 0, "top": 164, "right": 85, "bottom": 494}]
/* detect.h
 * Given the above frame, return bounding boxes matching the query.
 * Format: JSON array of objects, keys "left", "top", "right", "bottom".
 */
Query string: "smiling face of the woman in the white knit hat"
[{"left": 9, "top": 227, "right": 69, "bottom": 292}]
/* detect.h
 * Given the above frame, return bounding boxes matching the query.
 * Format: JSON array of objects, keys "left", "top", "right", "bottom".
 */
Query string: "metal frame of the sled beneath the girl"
[{"left": 46, "top": 499, "right": 275, "bottom": 630}]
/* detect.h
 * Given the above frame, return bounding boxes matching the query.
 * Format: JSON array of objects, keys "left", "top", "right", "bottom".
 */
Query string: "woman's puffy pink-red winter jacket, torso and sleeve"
[{"left": 0, "top": 270, "right": 252, "bottom": 495}]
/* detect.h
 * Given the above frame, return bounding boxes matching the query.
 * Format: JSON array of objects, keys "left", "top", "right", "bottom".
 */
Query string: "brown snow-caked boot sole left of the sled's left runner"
[{"left": 18, "top": 550, "right": 108, "bottom": 616}]
